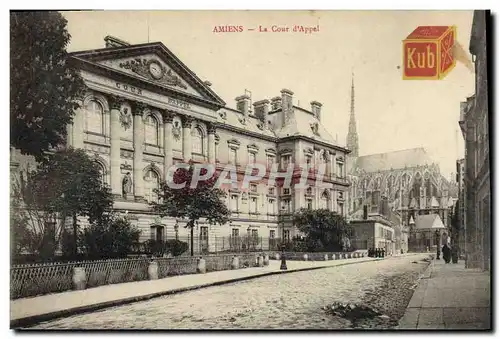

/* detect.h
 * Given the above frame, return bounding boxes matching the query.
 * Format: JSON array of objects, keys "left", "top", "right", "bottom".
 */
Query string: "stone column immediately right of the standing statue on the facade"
[{"left": 133, "top": 103, "right": 147, "bottom": 201}]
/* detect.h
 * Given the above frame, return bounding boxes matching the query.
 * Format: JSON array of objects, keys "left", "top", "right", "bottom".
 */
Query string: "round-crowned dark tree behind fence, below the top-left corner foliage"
[{"left": 14, "top": 148, "right": 113, "bottom": 257}]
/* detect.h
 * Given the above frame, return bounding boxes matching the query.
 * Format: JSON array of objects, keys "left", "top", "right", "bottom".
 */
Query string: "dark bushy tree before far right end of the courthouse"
[{"left": 293, "top": 208, "right": 351, "bottom": 251}]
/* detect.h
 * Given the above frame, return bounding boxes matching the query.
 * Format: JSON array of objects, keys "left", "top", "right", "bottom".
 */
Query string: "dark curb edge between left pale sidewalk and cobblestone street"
[{"left": 10, "top": 259, "right": 376, "bottom": 330}]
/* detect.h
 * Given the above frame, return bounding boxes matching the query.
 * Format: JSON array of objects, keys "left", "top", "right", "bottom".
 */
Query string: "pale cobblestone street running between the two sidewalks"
[{"left": 32, "top": 254, "right": 428, "bottom": 329}]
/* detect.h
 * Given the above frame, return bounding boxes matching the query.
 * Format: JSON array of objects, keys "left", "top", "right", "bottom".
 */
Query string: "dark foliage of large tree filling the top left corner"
[{"left": 10, "top": 11, "right": 85, "bottom": 161}]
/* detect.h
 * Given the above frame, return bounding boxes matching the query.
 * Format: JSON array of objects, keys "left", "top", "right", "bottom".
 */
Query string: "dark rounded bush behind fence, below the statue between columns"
[{"left": 80, "top": 214, "right": 141, "bottom": 259}]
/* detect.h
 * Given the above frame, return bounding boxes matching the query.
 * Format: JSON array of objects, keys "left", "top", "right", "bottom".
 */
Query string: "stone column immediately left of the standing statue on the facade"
[{"left": 109, "top": 96, "right": 123, "bottom": 197}]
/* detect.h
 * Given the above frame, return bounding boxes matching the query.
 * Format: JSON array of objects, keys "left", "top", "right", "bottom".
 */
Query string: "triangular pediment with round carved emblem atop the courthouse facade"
[{"left": 71, "top": 42, "right": 225, "bottom": 107}]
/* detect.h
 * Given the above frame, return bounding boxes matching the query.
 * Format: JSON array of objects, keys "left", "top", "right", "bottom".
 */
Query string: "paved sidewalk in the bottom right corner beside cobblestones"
[{"left": 398, "top": 259, "right": 491, "bottom": 330}]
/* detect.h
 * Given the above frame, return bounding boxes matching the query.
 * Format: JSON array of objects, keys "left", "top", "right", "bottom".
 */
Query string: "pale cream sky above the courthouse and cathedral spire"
[{"left": 63, "top": 11, "right": 474, "bottom": 178}]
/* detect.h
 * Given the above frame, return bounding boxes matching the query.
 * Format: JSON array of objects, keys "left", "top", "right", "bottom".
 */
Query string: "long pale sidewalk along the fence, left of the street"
[{"left": 10, "top": 257, "right": 379, "bottom": 328}]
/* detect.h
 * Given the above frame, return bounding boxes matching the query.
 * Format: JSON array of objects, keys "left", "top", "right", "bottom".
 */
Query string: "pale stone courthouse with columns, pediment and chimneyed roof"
[{"left": 11, "top": 36, "right": 349, "bottom": 255}]
